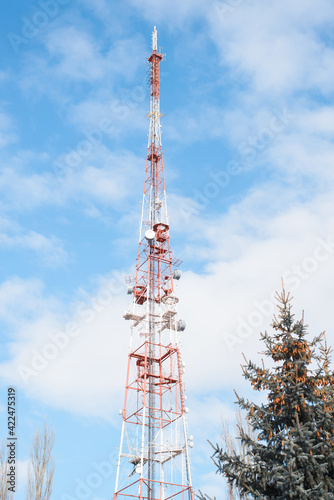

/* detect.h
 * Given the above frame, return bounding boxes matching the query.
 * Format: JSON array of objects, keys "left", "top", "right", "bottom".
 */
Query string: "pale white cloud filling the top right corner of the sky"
[{"left": 208, "top": 0, "right": 334, "bottom": 98}]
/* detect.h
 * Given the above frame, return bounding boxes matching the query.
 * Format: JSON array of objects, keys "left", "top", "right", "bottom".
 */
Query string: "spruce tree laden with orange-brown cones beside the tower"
[{"left": 213, "top": 288, "right": 334, "bottom": 500}]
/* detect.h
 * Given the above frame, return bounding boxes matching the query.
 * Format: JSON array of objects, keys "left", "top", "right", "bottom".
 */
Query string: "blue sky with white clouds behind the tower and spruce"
[{"left": 0, "top": 0, "right": 334, "bottom": 500}]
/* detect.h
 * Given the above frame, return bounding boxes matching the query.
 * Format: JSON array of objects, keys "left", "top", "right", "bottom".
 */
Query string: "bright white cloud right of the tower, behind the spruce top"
[{"left": 174, "top": 186, "right": 334, "bottom": 392}]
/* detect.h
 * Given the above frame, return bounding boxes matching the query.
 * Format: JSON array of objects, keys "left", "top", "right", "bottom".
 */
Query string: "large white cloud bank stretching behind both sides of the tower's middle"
[{"left": 1, "top": 184, "right": 334, "bottom": 417}]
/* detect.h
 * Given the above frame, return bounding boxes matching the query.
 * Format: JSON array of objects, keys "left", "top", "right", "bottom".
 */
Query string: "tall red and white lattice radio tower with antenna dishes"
[{"left": 114, "top": 27, "right": 193, "bottom": 500}]
